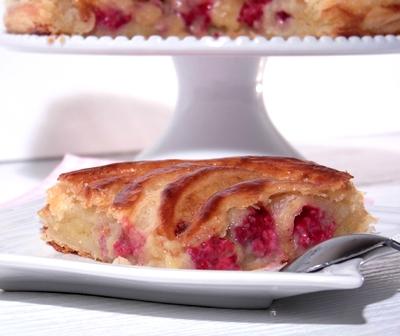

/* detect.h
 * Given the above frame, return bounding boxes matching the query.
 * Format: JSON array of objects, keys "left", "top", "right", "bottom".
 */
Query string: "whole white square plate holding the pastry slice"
[{"left": 0, "top": 200, "right": 400, "bottom": 308}]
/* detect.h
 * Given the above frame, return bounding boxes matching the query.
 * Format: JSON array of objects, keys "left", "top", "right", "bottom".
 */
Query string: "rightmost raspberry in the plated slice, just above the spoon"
[{"left": 293, "top": 205, "right": 336, "bottom": 249}]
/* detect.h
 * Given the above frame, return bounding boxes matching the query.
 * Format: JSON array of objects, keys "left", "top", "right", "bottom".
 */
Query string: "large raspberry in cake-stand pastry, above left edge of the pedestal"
[{"left": 180, "top": 0, "right": 212, "bottom": 33}]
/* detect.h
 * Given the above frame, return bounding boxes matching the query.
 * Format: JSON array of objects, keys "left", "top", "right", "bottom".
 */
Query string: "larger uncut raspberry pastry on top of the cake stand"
[{"left": 5, "top": 0, "right": 400, "bottom": 37}]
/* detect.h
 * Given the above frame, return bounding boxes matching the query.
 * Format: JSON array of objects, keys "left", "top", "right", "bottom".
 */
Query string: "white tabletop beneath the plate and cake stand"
[{"left": 0, "top": 134, "right": 400, "bottom": 335}]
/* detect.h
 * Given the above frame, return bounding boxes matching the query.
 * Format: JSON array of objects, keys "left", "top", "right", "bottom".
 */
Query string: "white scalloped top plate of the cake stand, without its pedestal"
[{"left": 0, "top": 32, "right": 400, "bottom": 56}]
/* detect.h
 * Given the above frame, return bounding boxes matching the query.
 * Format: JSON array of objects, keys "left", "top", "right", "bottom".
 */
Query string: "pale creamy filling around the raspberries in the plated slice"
[{"left": 41, "top": 188, "right": 372, "bottom": 270}]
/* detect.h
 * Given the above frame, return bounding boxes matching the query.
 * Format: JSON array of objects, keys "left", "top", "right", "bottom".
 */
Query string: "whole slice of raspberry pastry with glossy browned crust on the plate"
[{"left": 40, "top": 157, "right": 371, "bottom": 270}]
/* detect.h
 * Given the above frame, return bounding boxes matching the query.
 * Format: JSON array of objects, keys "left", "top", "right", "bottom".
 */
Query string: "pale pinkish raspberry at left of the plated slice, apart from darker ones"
[{"left": 113, "top": 219, "right": 145, "bottom": 258}]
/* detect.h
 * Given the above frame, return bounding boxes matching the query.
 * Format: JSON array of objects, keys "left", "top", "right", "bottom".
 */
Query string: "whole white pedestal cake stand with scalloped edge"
[{"left": 0, "top": 34, "right": 400, "bottom": 159}]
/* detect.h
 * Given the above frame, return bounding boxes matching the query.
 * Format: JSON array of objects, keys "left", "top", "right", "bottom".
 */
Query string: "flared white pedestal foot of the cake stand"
[{"left": 139, "top": 56, "right": 299, "bottom": 159}]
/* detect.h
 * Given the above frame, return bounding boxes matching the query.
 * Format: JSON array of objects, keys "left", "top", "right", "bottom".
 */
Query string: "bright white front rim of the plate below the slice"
[{"left": 0, "top": 252, "right": 364, "bottom": 289}]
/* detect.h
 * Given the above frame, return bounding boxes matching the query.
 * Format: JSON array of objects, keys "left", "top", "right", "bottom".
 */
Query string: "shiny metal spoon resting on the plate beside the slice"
[{"left": 282, "top": 234, "right": 400, "bottom": 273}]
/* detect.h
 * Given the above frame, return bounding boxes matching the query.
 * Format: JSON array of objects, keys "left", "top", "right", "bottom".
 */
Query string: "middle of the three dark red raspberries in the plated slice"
[{"left": 234, "top": 207, "right": 279, "bottom": 258}]
